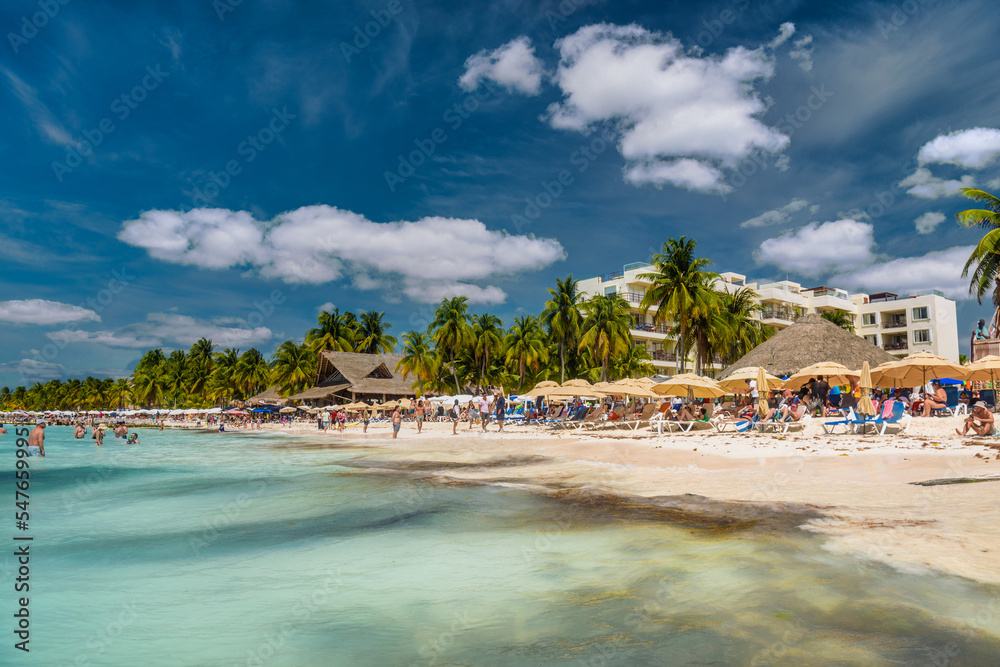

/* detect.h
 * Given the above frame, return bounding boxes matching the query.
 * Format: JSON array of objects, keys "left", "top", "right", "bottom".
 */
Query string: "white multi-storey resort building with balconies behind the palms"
[{"left": 580, "top": 262, "right": 958, "bottom": 376}]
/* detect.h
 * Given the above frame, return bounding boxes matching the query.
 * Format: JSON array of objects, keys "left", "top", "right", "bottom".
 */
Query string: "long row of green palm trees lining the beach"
[{"left": 0, "top": 237, "right": 772, "bottom": 409}]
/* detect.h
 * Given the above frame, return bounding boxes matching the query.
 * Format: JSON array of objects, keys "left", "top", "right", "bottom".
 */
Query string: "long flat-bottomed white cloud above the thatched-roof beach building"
[{"left": 118, "top": 206, "right": 565, "bottom": 303}]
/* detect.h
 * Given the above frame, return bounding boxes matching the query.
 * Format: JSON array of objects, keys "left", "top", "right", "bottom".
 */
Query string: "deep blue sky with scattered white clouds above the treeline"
[{"left": 0, "top": 0, "right": 1000, "bottom": 385}]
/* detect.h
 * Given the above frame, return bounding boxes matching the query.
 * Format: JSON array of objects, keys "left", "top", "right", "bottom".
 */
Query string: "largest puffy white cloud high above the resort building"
[{"left": 548, "top": 23, "right": 789, "bottom": 192}]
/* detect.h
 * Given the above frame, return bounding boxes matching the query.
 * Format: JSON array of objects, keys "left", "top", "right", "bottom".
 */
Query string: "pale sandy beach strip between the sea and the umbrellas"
[{"left": 47, "top": 417, "right": 1000, "bottom": 584}]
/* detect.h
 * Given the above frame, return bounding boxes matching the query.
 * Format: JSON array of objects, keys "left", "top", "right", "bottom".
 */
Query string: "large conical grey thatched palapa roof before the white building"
[{"left": 719, "top": 313, "right": 896, "bottom": 379}]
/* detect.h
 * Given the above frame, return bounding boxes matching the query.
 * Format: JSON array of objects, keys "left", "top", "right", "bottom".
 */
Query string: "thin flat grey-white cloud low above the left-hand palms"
[{"left": 45, "top": 313, "right": 273, "bottom": 349}]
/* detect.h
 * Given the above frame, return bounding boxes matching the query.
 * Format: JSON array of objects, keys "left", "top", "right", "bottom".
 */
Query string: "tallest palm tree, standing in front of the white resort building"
[{"left": 639, "top": 236, "right": 719, "bottom": 373}]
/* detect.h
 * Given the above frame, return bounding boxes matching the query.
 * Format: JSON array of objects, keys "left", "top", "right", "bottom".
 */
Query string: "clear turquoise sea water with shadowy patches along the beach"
[{"left": 0, "top": 427, "right": 1000, "bottom": 666}]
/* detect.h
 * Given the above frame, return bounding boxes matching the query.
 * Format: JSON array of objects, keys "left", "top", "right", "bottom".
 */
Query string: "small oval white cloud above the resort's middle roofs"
[{"left": 756, "top": 219, "right": 875, "bottom": 277}]
